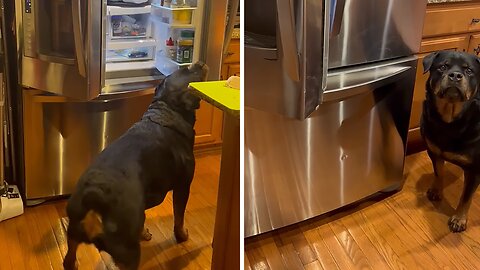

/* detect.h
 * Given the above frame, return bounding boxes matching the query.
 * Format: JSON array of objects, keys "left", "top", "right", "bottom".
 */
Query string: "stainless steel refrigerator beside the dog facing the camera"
[{"left": 244, "top": 0, "right": 427, "bottom": 237}]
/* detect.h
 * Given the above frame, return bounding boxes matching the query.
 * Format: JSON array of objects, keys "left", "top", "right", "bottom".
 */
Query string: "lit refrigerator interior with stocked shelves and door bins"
[{"left": 105, "top": 0, "right": 204, "bottom": 86}]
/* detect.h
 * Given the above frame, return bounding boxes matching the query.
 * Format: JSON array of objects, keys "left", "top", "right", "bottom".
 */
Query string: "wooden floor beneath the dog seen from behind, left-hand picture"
[{"left": 0, "top": 154, "right": 220, "bottom": 270}]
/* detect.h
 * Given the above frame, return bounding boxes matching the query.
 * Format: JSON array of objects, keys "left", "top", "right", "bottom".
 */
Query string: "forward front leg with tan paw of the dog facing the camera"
[{"left": 448, "top": 171, "right": 480, "bottom": 232}]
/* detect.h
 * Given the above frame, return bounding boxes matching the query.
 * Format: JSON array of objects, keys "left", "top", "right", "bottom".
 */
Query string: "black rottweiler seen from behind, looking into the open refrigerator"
[{"left": 63, "top": 63, "right": 208, "bottom": 269}]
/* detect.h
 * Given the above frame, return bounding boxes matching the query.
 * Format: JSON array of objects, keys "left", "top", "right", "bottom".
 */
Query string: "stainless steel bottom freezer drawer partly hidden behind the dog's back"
[{"left": 23, "top": 89, "right": 153, "bottom": 200}]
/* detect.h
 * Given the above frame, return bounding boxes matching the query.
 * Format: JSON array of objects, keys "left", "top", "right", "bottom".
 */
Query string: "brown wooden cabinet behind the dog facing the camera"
[{"left": 407, "top": 2, "right": 480, "bottom": 153}]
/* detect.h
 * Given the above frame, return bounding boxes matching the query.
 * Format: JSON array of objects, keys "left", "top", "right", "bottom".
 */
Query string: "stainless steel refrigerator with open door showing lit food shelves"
[{"left": 15, "top": 0, "right": 228, "bottom": 204}]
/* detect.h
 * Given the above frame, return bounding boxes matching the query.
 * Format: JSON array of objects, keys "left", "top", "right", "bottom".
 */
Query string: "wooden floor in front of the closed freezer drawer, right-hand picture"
[{"left": 244, "top": 152, "right": 480, "bottom": 270}]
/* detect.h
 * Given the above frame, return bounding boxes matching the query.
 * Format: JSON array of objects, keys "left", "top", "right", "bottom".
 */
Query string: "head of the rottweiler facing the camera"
[{"left": 423, "top": 51, "right": 480, "bottom": 103}]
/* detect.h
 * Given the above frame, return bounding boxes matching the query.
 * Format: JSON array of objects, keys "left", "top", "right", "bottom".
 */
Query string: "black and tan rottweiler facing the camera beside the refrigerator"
[{"left": 420, "top": 51, "right": 480, "bottom": 232}]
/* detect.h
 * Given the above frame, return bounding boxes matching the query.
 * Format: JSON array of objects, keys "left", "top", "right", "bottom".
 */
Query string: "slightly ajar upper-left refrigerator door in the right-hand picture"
[{"left": 244, "top": 0, "right": 330, "bottom": 119}]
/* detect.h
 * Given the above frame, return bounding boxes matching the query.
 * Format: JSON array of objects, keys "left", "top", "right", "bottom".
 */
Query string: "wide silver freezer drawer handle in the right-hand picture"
[{"left": 323, "top": 61, "right": 412, "bottom": 102}]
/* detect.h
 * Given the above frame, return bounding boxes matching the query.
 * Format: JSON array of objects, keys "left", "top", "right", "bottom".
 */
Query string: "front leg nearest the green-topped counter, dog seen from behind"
[{"left": 173, "top": 181, "right": 191, "bottom": 243}]
